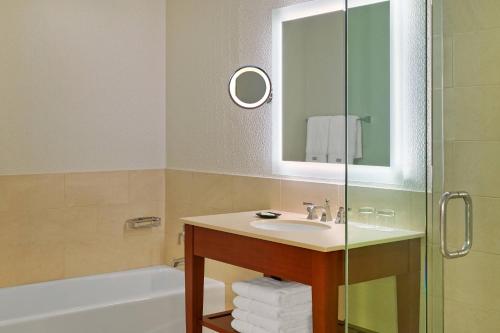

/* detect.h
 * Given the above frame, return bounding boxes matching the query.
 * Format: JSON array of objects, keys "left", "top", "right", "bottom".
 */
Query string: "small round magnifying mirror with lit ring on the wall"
[{"left": 229, "top": 66, "right": 272, "bottom": 109}]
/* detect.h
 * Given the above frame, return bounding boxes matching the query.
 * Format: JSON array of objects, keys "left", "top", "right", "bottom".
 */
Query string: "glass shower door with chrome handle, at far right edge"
[{"left": 431, "top": 0, "right": 500, "bottom": 333}]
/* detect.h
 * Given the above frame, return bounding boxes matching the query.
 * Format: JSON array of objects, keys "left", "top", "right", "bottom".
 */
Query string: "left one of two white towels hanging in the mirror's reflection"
[{"left": 306, "top": 116, "right": 331, "bottom": 163}]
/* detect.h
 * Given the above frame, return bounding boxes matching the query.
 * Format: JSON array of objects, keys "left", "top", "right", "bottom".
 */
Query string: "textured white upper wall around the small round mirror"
[{"left": 167, "top": 0, "right": 305, "bottom": 176}]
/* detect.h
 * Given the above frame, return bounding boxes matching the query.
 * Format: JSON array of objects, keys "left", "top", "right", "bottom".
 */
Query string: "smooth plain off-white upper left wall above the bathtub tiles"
[{"left": 0, "top": 0, "right": 168, "bottom": 174}]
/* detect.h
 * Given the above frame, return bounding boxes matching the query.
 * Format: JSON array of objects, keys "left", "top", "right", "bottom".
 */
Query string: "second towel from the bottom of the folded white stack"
[{"left": 233, "top": 296, "right": 312, "bottom": 320}]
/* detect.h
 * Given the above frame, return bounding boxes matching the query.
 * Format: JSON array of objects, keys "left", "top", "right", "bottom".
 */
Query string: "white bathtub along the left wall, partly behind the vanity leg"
[{"left": 0, "top": 266, "right": 224, "bottom": 333}]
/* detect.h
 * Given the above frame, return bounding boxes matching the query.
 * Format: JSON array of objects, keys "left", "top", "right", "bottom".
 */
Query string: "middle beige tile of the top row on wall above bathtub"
[{"left": 65, "top": 171, "right": 129, "bottom": 207}]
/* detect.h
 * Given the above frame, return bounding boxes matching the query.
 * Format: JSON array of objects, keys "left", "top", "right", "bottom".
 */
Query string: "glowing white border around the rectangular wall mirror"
[{"left": 272, "top": 0, "right": 422, "bottom": 187}]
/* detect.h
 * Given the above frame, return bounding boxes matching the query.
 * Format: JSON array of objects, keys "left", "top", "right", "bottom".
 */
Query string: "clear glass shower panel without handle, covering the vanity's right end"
[{"left": 345, "top": 0, "right": 428, "bottom": 333}]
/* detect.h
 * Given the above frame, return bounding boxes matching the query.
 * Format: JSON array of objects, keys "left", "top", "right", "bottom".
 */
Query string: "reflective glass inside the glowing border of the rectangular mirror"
[{"left": 281, "top": 1, "right": 390, "bottom": 166}]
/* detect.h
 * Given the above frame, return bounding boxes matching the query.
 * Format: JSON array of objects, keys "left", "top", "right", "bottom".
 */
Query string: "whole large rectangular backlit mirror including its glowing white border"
[{"left": 272, "top": 0, "right": 427, "bottom": 188}]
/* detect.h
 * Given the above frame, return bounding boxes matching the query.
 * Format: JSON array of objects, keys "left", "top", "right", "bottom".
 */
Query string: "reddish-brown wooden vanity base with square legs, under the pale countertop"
[{"left": 185, "top": 224, "right": 420, "bottom": 333}]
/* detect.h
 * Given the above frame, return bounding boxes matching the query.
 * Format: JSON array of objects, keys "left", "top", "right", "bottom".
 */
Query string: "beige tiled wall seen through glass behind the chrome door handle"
[{"left": 443, "top": 0, "right": 500, "bottom": 333}]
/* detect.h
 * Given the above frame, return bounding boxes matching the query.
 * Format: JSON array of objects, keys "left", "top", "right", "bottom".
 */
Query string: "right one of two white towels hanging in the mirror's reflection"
[{"left": 327, "top": 115, "right": 363, "bottom": 164}]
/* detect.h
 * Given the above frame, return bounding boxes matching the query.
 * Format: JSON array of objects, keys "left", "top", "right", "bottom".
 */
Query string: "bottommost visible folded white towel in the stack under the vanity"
[{"left": 232, "top": 309, "right": 312, "bottom": 333}]
